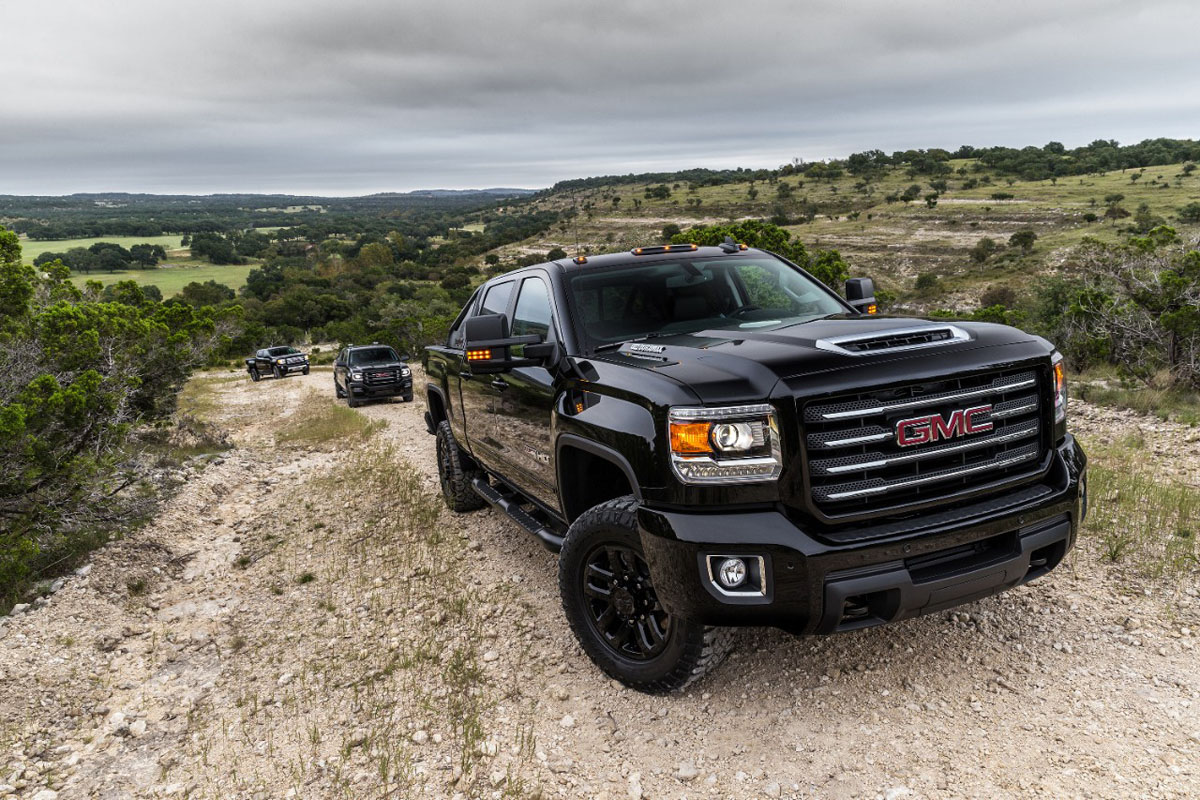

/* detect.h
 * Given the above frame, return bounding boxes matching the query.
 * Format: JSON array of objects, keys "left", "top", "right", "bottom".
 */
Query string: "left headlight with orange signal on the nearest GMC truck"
[{"left": 667, "top": 403, "right": 784, "bottom": 483}]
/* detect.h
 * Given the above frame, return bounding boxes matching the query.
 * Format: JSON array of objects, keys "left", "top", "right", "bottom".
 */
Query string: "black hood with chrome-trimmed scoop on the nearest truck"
[{"left": 594, "top": 314, "right": 1038, "bottom": 403}]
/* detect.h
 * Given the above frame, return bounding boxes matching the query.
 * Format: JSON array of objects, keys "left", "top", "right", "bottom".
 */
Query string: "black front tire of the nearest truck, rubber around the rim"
[{"left": 558, "top": 495, "right": 732, "bottom": 694}]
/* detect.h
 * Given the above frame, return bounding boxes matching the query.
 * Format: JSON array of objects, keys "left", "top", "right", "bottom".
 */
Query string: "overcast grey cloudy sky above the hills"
[{"left": 0, "top": 0, "right": 1200, "bottom": 194}]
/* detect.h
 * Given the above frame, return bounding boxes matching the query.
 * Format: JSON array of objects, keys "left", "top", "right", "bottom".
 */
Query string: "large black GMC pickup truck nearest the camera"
[{"left": 425, "top": 242, "right": 1087, "bottom": 692}]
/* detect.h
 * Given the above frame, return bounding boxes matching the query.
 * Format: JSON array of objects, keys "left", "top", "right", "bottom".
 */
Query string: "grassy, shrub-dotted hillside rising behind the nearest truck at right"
[{"left": 513, "top": 160, "right": 1200, "bottom": 309}]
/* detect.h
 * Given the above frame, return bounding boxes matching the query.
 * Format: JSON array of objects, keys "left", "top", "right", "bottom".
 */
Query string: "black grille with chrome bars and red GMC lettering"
[{"left": 803, "top": 368, "right": 1045, "bottom": 518}]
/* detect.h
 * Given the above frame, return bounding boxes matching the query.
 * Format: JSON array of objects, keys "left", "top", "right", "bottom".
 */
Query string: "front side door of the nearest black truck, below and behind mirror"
[{"left": 490, "top": 276, "right": 559, "bottom": 510}]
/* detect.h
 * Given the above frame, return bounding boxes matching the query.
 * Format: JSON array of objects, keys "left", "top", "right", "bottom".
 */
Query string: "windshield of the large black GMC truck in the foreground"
[{"left": 568, "top": 257, "right": 846, "bottom": 348}]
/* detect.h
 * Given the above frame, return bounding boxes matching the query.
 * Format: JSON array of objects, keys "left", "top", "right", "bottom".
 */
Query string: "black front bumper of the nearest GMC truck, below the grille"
[{"left": 638, "top": 435, "right": 1087, "bottom": 633}]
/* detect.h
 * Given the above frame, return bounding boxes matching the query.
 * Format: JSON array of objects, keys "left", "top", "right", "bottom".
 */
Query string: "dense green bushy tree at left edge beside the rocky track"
[{"left": 0, "top": 231, "right": 235, "bottom": 606}]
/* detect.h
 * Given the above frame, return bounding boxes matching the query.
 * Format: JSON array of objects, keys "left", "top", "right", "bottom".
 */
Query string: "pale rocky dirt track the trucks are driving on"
[{"left": 0, "top": 371, "right": 1200, "bottom": 800}]
